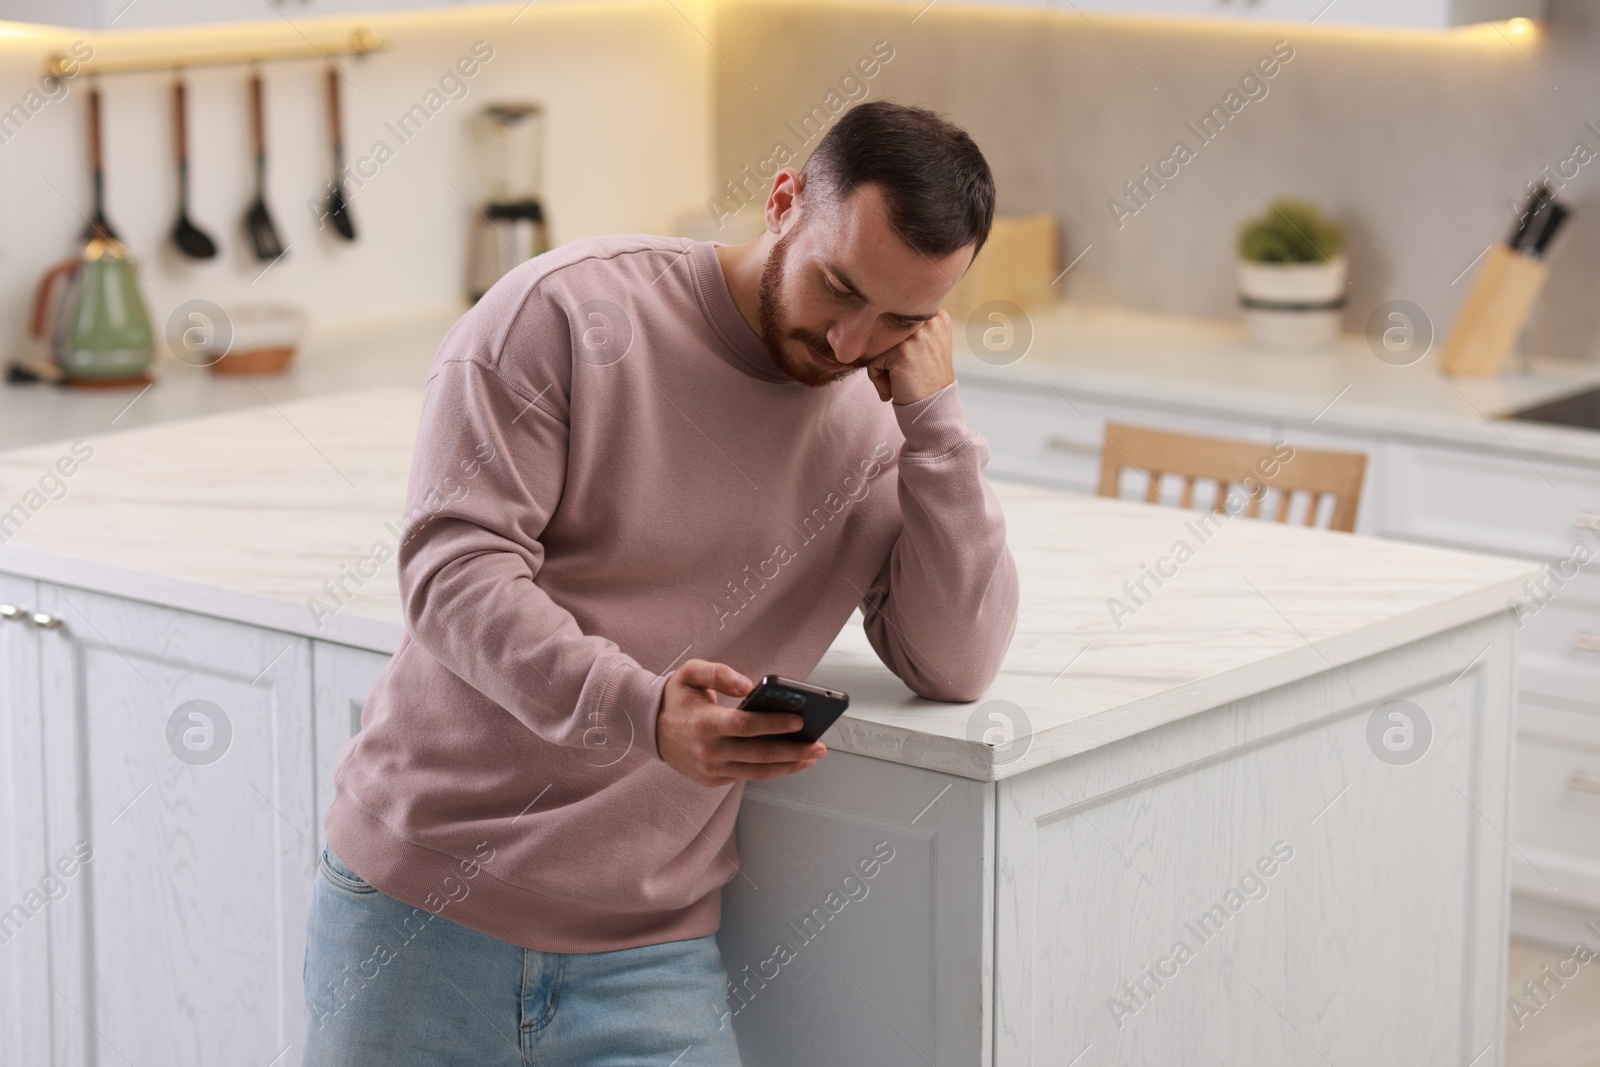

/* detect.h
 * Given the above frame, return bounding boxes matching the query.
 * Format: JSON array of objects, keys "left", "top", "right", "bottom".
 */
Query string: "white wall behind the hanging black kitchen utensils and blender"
[{"left": 0, "top": 0, "right": 715, "bottom": 358}]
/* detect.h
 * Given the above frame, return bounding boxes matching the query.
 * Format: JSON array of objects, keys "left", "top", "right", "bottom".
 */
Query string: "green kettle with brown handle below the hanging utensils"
[{"left": 32, "top": 230, "right": 155, "bottom": 386}]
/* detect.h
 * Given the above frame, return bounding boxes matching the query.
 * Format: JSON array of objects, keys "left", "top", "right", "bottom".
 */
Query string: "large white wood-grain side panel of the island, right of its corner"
[{"left": 995, "top": 614, "right": 1512, "bottom": 1067}]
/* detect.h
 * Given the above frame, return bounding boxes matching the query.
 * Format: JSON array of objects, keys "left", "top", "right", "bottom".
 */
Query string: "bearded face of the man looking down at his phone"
[{"left": 758, "top": 186, "right": 973, "bottom": 386}]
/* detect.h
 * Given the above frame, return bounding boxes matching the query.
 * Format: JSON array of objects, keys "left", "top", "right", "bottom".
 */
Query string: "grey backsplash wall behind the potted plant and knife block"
[{"left": 706, "top": 0, "right": 1600, "bottom": 358}]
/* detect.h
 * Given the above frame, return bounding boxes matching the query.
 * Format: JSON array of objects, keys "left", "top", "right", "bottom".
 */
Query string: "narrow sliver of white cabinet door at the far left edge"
[{"left": 0, "top": 574, "right": 50, "bottom": 1064}]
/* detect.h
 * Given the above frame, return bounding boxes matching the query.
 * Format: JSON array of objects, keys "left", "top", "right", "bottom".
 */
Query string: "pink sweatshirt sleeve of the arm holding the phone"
[{"left": 398, "top": 286, "right": 666, "bottom": 761}]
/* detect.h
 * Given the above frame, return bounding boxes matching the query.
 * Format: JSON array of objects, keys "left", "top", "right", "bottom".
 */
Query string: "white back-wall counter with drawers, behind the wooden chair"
[{"left": 957, "top": 307, "right": 1600, "bottom": 947}]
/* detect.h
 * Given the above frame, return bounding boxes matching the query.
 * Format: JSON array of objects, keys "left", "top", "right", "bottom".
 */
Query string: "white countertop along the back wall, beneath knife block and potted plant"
[{"left": 957, "top": 306, "right": 1600, "bottom": 466}]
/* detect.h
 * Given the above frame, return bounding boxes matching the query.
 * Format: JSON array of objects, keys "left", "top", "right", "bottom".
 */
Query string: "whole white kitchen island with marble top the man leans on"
[{"left": 0, "top": 389, "right": 1536, "bottom": 1067}]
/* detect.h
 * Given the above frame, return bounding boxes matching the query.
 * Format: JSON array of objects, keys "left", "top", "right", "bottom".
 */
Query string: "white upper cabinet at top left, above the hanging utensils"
[{"left": 0, "top": 0, "right": 469, "bottom": 30}]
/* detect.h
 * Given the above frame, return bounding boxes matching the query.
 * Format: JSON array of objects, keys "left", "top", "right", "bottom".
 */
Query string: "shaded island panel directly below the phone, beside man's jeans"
[{"left": 717, "top": 752, "right": 994, "bottom": 1067}]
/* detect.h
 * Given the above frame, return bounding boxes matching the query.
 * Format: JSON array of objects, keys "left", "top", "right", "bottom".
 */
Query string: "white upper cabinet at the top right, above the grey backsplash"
[{"left": 1046, "top": 0, "right": 1544, "bottom": 29}]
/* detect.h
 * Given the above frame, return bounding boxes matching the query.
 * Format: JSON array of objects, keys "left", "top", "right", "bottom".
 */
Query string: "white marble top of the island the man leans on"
[{"left": 0, "top": 389, "right": 1536, "bottom": 779}]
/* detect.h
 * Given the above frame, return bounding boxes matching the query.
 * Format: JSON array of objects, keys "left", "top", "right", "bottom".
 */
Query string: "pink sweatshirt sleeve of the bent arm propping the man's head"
[{"left": 861, "top": 382, "right": 1018, "bottom": 701}]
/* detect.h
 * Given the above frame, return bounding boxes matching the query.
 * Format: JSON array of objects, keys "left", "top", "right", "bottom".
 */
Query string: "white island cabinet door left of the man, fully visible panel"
[{"left": 37, "top": 582, "right": 317, "bottom": 1067}]
